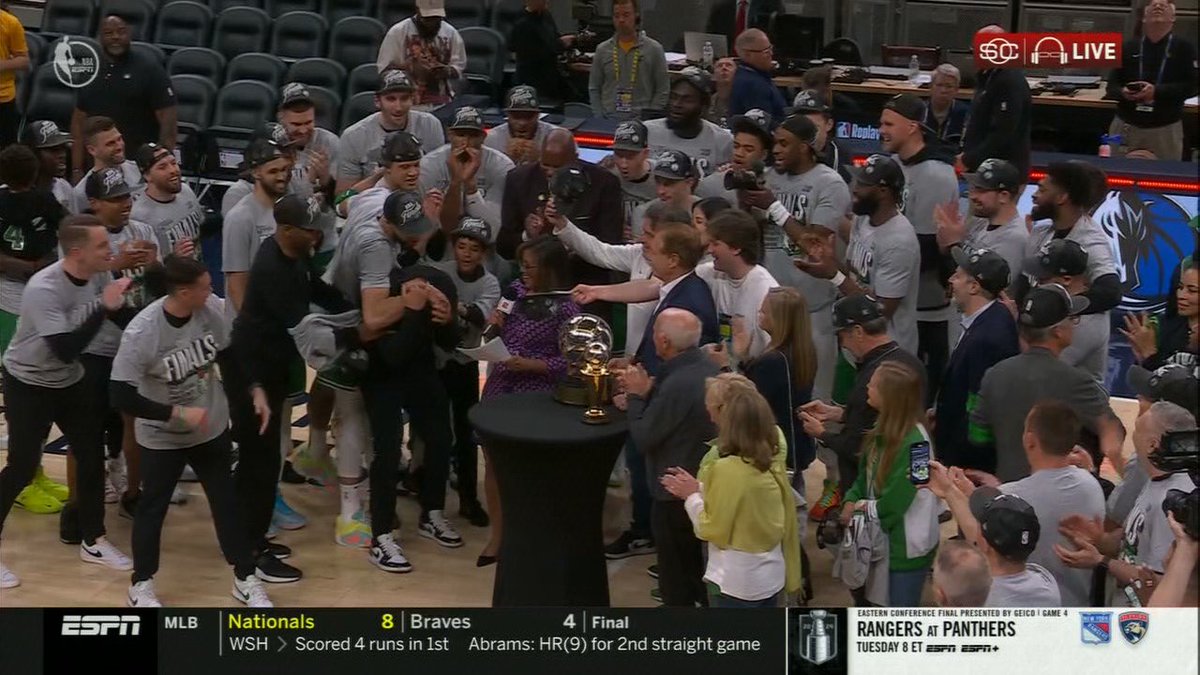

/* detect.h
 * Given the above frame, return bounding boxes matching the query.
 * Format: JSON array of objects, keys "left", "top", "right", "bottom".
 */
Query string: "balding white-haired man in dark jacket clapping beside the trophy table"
[{"left": 618, "top": 307, "right": 719, "bottom": 607}]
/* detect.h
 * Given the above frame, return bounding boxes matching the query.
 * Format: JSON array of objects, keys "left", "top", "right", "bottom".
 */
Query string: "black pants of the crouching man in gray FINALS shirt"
[{"left": 132, "top": 431, "right": 254, "bottom": 584}]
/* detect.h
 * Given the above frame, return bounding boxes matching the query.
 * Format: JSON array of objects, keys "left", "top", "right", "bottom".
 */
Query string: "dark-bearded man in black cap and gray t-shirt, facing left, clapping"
[{"left": 796, "top": 155, "right": 920, "bottom": 354}]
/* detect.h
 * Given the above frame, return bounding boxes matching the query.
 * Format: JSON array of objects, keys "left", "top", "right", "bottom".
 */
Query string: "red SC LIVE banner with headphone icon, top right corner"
[{"left": 973, "top": 32, "right": 1121, "bottom": 68}]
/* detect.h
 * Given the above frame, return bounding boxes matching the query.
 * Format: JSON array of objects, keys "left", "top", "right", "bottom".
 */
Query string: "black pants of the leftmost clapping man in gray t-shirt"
[{"left": 0, "top": 369, "right": 104, "bottom": 543}]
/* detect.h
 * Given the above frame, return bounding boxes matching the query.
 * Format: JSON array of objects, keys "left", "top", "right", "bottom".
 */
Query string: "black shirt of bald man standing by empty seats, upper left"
[{"left": 76, "top": 52, "right": 175, "bottom": 154}]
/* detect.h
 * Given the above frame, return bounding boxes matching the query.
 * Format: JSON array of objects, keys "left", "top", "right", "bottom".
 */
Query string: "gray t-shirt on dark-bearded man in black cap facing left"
[{"left": 846, "top": 214, "right": 920, "bottom": 354}]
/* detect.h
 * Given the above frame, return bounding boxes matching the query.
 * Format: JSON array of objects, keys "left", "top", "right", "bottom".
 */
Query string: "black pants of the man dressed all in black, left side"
[{"left": 223, "top": 368, "right": 288, "bottom": 552}]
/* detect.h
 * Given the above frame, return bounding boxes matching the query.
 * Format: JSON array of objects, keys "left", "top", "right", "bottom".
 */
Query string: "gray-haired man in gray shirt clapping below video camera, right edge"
[{"left": 1055, "top": 401, "right": 1196, "bottom": 607}]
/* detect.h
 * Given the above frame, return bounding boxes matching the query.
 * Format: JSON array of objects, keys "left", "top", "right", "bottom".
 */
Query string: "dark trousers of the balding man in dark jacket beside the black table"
[{"left": 650, "top": 500, "right": 708, "bottom": 607}]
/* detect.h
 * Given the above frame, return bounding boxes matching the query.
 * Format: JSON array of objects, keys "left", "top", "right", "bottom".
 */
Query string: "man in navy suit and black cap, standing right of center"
[{"left": 934, "top": 246, "right": 1020, "bottom": 471}]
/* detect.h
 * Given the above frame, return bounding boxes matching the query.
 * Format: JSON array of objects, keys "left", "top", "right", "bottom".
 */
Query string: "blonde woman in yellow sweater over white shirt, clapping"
[{"left": 661, "top": 374, "right": 800, "bottom": 608}]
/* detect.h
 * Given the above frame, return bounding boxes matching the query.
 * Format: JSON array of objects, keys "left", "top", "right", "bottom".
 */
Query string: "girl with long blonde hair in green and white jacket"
[{"left": 841, "top": 362, "right": 937, "bottom": 607}]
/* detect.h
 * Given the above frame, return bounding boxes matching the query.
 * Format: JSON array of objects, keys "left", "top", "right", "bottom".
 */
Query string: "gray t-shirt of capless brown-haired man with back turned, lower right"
[{"left": 1000, "top": 466, "right": 1104, "bottom": 607}]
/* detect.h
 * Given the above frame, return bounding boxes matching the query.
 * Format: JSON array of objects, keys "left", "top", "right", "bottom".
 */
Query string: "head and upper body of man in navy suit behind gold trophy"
[{"left": 636, "top": 222, "right": 720, "bottom": 376}]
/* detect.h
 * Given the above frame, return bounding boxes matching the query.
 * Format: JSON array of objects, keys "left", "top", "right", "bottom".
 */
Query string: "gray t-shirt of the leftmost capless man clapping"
[{"left": 4, "top": 261, "right": 106, "bottom": 389}]
